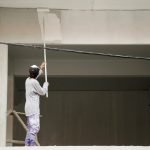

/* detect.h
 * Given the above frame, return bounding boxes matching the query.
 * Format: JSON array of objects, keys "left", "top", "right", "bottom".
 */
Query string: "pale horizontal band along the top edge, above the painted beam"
[{"left": 0, "top": 0, "right": 150, "bottom": 10}]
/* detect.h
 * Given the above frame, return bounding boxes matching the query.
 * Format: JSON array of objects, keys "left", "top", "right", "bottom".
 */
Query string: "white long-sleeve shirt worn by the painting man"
[{"left": 25, "top": 77, "right": 48, "bottom": 116}]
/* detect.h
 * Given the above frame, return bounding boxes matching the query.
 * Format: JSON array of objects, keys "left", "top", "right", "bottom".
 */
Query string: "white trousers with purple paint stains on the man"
[{"left": 25, "top": 115, "right": 40, "bottom": 146}]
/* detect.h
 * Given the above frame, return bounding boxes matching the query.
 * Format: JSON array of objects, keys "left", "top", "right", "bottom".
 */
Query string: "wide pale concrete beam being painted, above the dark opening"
[{"left": 0, "top": 8, "right": 150, "bottom": 44}]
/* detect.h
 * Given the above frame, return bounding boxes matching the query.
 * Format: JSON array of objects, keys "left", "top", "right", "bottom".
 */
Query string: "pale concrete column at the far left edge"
[{"left": 0, "top": 44, "right": 8, "bottom": 146}]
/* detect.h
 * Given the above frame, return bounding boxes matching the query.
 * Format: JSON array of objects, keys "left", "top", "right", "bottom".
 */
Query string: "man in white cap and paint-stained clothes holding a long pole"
[{"left": 25, "top": 63, "right": 49, "bottom": 146}]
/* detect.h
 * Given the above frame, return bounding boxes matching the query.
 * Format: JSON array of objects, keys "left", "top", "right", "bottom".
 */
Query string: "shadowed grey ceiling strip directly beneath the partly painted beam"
[{"left": 9, "top": 45, "right": 150, "bottom": 60}]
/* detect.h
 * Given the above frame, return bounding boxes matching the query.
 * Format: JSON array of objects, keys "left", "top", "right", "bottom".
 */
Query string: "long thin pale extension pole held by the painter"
[{"left": 43, "top": 16, "right": 48, "bottom": 97}]
